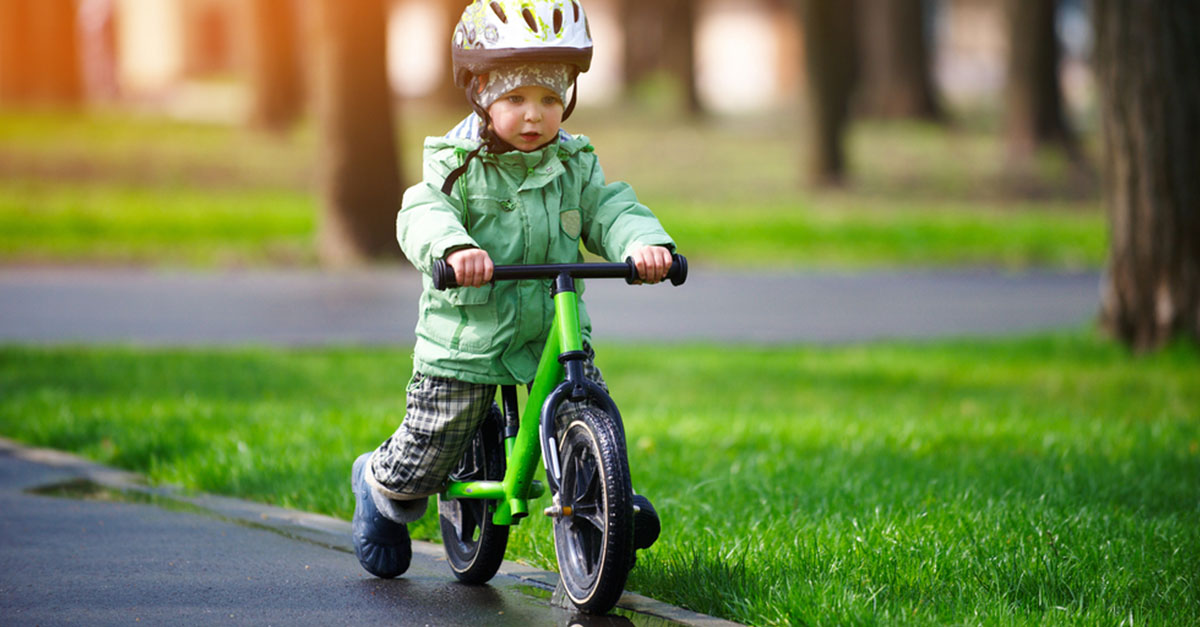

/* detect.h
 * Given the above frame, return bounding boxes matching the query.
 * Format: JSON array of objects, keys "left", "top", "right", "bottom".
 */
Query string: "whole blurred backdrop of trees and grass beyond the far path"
[{"left": 0, "top": 0, "right": 1194, "bottom": 345}]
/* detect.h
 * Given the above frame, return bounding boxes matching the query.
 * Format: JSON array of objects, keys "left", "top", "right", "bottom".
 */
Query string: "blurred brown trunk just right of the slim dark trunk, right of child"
[{"left": 858, "top": 0, "right": 943, "bottom": 120}]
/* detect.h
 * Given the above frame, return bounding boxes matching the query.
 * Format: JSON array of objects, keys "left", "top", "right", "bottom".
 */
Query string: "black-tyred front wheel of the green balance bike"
[{"left": 554, "top": 408, "right": 634, "bottom": 614}]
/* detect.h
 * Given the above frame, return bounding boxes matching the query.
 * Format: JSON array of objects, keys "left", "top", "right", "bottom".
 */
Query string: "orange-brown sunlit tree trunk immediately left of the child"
[{"left": 313, "top": 0, "right": 401, "bottom": 265}]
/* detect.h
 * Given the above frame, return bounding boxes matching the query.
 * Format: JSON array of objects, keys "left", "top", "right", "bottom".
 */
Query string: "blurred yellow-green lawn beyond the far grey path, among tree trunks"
[{"left": 0, "top": 107, "right": 1106, "bottom": 269}]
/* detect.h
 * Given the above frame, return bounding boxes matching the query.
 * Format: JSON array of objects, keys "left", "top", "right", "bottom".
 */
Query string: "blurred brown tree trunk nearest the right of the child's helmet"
[{"left": 618, "top": 0, "right": 703, "bottom": 114}]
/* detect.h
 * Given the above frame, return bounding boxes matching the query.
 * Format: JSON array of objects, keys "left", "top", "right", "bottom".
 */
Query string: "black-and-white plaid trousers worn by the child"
[{"left": 371, "top": 350, "right": 607, "bottom": 498}]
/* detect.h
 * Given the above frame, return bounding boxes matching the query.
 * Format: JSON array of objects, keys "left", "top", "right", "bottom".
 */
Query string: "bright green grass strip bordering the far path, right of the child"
[{"left": 654, "top": 197, "right": 1106, "bottom": 270}]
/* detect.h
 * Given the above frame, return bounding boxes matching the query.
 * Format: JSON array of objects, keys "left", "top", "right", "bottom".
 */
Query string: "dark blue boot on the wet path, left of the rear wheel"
[{"left": 350, "top": 453, "right": 413, "bottom": 579}]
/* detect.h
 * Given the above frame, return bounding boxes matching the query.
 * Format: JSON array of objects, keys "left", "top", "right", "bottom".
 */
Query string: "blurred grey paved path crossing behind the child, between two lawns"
[{"left": 0, "top": 267, "right": 1098, "bottom": 345}]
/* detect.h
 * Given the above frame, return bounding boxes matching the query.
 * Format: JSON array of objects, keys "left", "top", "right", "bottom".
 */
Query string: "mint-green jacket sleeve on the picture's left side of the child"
[{"left": 396, "top": 151, "right": 479, "bottom": 274}]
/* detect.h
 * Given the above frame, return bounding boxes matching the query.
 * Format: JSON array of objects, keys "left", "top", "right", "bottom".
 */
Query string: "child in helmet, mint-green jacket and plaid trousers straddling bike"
[{"left": 352, "top": 0, "right": 674, "bottom": 578}]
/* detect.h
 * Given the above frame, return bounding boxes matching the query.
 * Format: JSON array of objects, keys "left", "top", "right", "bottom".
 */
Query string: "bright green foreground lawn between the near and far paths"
[{"left": 0, "top": 332, "right": 1200, "bottom": 625}]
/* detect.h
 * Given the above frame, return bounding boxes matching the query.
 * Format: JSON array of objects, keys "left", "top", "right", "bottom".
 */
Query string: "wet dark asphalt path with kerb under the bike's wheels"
[{"left": 0, "top": 438, "right": 732, "bottom": 627}]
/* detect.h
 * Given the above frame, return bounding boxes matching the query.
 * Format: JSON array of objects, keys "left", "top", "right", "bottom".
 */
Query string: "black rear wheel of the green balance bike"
[{"left": 438, "top": 408, "right": 509, "bottom": 584}]
